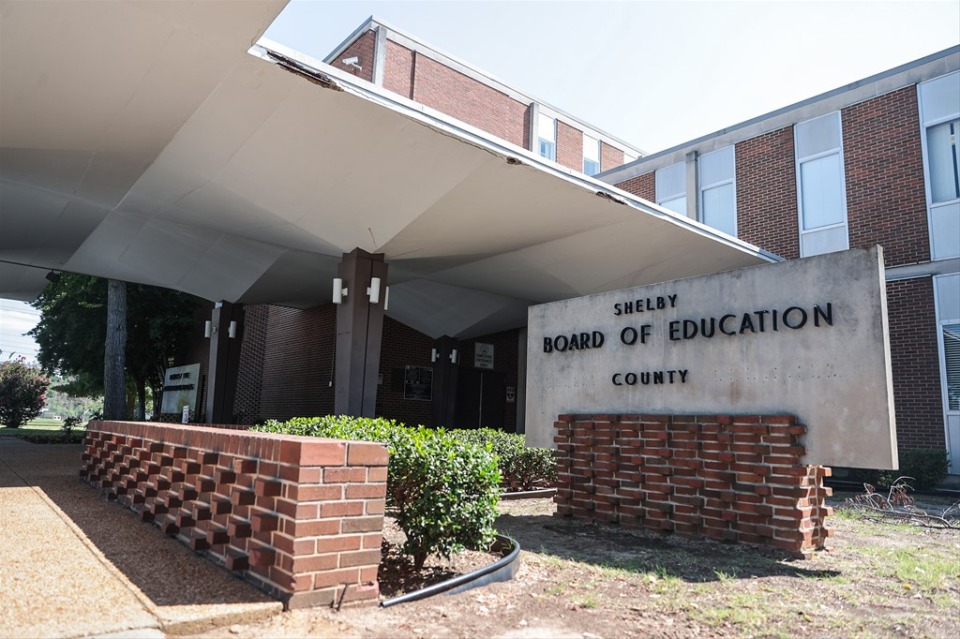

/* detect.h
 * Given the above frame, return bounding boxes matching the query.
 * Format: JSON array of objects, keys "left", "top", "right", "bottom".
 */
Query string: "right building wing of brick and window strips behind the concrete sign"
[{"left": 599, "top": 47, "right": 960, "bottom": 474}]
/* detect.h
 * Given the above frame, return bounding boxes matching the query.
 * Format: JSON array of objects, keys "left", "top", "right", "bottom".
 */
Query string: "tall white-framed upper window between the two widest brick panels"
[{"left": 794, "top": 111, "right": 850, "bottom": 257}]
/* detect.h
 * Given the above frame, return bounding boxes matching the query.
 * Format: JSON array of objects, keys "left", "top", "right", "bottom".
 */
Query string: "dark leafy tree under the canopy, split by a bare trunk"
[{"left": 30, "top": 273, "right": 199, "bottom": 419}]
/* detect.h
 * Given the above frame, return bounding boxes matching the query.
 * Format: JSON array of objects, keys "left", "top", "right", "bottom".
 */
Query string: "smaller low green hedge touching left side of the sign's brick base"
[{"left": 450, "top": 428, "right": 557, "bottom": 490}]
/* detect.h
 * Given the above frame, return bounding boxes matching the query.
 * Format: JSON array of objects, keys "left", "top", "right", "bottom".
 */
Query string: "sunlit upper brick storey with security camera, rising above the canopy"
[{"left": 323, "top": 16, "right": 643, "bottom": 175}]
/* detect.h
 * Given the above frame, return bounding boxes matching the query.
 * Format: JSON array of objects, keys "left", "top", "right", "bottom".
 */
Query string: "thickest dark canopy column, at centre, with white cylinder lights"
[{"left": 333, "top": 248, "right": 387, "bottom": 417}]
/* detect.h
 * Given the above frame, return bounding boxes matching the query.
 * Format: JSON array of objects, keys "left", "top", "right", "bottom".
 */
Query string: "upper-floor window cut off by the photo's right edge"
[{"left": 918, "top": 73, "right": 960, "bottom": 260}]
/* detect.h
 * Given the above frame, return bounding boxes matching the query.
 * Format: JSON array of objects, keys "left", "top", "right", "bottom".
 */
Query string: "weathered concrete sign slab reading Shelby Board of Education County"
[{"left": 526, "top": 247, "right": 898, "bottom": 469}]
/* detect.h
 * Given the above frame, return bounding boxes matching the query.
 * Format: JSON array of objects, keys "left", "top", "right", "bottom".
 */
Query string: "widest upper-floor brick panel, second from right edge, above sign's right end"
[{"left": 840, "top": 86, "right": 930, "bottom": 266}]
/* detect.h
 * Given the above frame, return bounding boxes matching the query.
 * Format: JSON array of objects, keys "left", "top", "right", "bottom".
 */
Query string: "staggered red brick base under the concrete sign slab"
[{"left": 554, "top": 415, "right": 833, "bottom": 556}]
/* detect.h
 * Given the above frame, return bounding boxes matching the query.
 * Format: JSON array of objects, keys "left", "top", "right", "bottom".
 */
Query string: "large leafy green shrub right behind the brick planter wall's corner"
[{"left": 252, "top": 416, "right": 500, "bottom": 569}]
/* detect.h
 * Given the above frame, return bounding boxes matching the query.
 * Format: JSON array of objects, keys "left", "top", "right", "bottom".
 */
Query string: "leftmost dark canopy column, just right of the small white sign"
[{"left": 205, "top": 302, "right": 244, "bottom": 424}]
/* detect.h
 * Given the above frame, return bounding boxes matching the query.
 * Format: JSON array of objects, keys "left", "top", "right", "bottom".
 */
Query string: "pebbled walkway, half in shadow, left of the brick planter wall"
[{"left": 0, "top": 438, "right": 282, "bottom": 637}]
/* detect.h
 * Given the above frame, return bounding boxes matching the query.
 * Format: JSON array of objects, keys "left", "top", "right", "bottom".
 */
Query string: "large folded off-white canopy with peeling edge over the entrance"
[{"left": 0, "top": 0, "right": 775, "bottom": 337}]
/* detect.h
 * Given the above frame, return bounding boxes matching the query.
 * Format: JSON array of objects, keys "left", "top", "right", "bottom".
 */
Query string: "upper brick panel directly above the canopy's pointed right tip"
[{"left": 735, "top": 127, "right": 800, "bottom": 259}]
